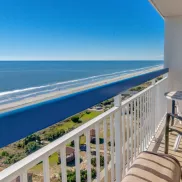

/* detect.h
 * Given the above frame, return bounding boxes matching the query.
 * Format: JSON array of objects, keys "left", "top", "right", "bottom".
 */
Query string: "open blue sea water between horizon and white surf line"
[{"left": 0, "top": 61, "right": 163, "bottom": 92}]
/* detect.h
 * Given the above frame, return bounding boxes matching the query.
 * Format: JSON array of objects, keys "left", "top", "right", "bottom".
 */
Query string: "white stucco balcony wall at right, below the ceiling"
[{"left": 164, "top": 16, "right": 182, "bottom": 90}]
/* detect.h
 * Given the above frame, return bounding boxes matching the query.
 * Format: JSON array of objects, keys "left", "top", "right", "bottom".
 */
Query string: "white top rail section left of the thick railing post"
[{"left": 0, "top": 107, "right": 119, "bottom": 181}]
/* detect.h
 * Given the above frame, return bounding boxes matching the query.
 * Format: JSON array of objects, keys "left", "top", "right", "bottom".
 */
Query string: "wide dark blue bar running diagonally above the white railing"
[{"left": 0, "top": 68, "right": 168, "bottom": 147}]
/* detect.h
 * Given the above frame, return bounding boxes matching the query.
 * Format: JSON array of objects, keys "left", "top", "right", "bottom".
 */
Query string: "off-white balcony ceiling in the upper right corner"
[{"left": 149, "top": 0, "right": 182, "bottom": 17}]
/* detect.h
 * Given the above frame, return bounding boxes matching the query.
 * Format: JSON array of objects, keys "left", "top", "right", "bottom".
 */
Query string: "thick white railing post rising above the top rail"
[{"left": 114, "top": 94, "right": 121, "bottom": 182}]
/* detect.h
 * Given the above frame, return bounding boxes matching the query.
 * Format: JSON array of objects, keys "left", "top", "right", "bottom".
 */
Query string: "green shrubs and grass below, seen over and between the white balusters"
[{"left": 0, "top": 78, "right": 155, "bottom": 182}]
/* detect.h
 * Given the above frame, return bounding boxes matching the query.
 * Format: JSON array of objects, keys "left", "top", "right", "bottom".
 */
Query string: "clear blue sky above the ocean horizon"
[{"left": 0, "top": 0, "right": 164, "bottom": 60}]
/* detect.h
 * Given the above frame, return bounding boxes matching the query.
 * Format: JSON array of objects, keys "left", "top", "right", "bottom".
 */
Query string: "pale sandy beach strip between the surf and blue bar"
[{"left": 0, "top": 66, "right": 161, "bottom": 113}]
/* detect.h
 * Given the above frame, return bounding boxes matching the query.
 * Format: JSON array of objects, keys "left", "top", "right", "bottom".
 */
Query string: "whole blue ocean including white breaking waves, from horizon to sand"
[{"left": 0, "top": 61, "right": 163, "bottom": 105}]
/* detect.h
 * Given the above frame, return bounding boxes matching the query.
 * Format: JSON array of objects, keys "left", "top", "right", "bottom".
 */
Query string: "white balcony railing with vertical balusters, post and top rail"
[{"left": 0, "top": 74, "right": 167, "bottom": 182}]
